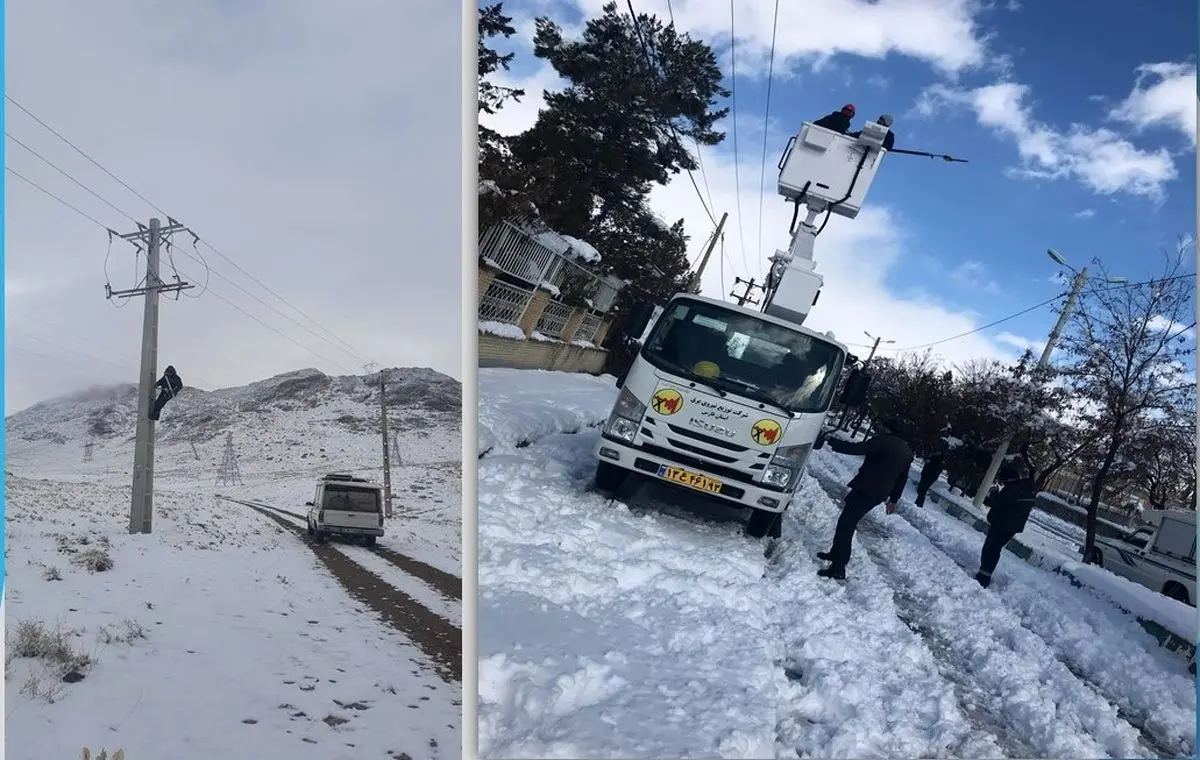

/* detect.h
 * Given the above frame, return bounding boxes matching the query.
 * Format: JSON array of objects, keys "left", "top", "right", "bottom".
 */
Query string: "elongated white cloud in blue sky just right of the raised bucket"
[{"left": 916, "top": 82, "right": 1178, "bottom": 201}]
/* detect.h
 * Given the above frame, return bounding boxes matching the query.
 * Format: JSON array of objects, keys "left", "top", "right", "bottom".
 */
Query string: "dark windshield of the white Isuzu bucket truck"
[{"left": 642, "top": 299, "right": 845, "bottom": 413}]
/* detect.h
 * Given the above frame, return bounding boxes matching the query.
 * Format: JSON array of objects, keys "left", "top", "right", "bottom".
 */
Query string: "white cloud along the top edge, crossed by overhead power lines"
[{"left": 512, "top": 0, "right": 989, "bottom": 77}]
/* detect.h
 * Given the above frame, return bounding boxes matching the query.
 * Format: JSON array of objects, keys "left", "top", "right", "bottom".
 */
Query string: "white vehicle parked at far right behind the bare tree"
[{"left": 1088, "top": 509, "right": 1196, "bottom": 606}]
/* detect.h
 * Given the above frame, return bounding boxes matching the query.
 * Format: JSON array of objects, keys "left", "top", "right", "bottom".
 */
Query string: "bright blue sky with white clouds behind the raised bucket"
[{"left": 482, "top": 0, "right": 1198, "bottom": 361}]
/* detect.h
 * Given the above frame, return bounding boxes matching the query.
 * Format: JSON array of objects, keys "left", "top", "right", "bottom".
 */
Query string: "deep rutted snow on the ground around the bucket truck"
[{"left": 478, "top": 370, "right": 1196, "bottom": 758}]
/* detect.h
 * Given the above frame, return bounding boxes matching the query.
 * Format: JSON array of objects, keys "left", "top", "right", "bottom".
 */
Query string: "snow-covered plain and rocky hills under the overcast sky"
[{"left": 5, "top": 369, "right": 462, "bottom": 760}]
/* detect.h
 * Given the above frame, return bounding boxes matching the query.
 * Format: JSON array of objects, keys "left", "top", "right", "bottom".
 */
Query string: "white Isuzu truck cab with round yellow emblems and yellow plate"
[{"left": 595, "top": 294, "right": 847, "bottom": 538}]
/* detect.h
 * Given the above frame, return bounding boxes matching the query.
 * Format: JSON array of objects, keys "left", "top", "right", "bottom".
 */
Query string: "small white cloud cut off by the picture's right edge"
[{"left": 1109, "top": 62, "right": 1196, "bottom": 146}]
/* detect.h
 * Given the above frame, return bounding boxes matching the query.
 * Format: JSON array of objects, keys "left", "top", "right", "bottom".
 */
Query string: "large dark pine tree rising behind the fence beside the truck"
[{"left": 498, "top": 2, "right": 727, "bottom": 295}]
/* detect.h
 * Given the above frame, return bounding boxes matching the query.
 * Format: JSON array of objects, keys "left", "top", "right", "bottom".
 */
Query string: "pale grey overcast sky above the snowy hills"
[{"left": 5, "top": 0, "right": 462, "bottom": 414}]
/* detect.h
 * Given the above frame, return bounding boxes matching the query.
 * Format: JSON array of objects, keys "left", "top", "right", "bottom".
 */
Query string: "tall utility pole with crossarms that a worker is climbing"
[{"left": 104, "top": 217, "right": 196, "bottom": 533}]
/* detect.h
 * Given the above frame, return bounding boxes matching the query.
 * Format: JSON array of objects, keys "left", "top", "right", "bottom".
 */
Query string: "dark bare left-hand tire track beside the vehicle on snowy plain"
[{"left": 223, "top": 497, "right": 462, "bottom": 683}]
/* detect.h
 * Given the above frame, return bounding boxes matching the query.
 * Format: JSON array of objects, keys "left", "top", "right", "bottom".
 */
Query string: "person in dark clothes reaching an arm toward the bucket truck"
[{"left": 817, "top": 419, "right": 913, "bottom": 580}]
